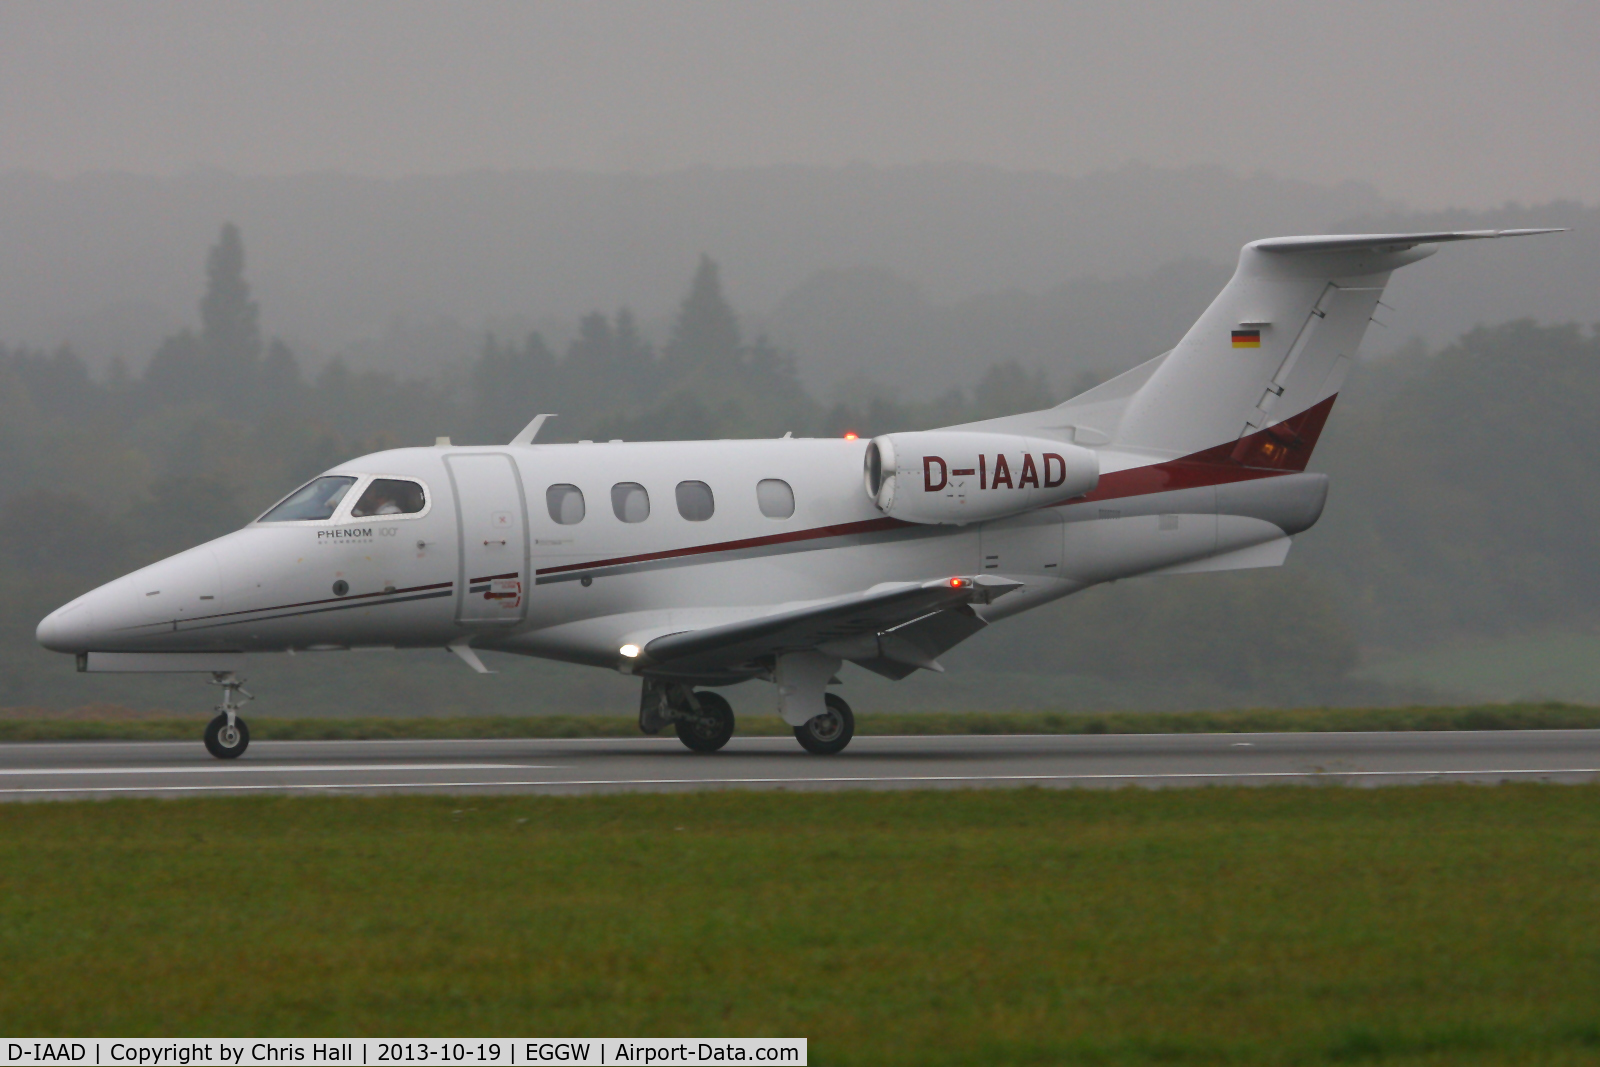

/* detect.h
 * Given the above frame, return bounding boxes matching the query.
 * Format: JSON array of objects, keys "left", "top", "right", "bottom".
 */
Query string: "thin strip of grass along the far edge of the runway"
[{"left": 0, "top": 704, "right": 1600, "bottom": 741}]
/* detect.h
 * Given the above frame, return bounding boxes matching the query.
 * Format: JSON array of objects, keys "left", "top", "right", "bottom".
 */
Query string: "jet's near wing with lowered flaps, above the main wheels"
[{"left": 642, "top": 574, "right": 1022, "bottom": 673}]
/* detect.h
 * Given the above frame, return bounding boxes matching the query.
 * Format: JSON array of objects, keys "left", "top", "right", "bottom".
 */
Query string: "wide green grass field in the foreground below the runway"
[{"left": 0, "top": 785, "right": 1600, "bottom": 1065}]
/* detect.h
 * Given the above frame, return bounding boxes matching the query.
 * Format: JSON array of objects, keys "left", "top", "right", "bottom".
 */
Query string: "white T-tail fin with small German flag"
[{"left": 1107, "top": 230, "right": 1555, "bottom": 459}]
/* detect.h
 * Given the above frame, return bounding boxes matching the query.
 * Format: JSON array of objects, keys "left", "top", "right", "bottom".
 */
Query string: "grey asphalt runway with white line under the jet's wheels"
[{"left": 0, "top": 729, "right": 1600, "bottom": 800}]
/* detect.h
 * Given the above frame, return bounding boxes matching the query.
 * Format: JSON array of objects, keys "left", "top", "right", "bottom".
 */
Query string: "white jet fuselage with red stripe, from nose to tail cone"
[{"left": 38, "top": 438, "right": 1320, "bottom": 667}]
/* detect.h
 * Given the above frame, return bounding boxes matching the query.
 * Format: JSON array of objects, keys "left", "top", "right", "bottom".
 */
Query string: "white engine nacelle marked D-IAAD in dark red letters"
[{"left": 864, "top": 430, "right": 1099, "bottom": 525}]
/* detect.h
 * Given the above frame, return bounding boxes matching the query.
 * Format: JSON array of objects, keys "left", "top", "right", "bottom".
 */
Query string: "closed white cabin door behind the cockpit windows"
[{"left": 445, "top": 453, "right": 530, "bottom": 624}]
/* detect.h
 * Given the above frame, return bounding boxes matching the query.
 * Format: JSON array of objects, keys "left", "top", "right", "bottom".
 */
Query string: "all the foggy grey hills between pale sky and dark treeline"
[{"left": 0, "top": 165, "right": 1600, "bottom": 395}]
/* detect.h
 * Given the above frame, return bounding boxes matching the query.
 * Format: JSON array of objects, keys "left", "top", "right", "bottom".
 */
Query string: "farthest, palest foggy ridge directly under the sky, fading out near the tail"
[{"left": 0, "top": 165, "right": 1395, "bottom": 371}]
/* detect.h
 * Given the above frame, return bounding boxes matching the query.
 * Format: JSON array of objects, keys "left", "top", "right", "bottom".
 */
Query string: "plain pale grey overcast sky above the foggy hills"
[{"left": 0, "top": 0, "right": 1600, "bottom": 206}]
